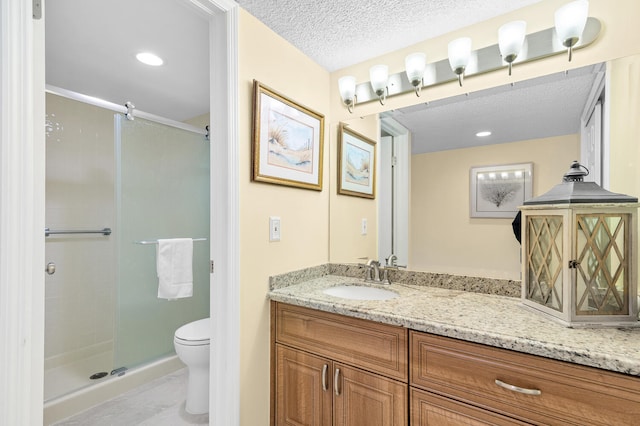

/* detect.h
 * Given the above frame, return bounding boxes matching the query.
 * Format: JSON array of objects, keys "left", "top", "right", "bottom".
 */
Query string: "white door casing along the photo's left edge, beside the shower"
[{"left": 0, "top": 0, "right": 45, "bottom": 425}]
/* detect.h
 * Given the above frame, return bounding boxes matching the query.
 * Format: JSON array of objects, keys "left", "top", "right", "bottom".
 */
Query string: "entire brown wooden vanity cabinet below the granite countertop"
[{"left": 271, "top": 302, "right": 640, "bottom": 426}]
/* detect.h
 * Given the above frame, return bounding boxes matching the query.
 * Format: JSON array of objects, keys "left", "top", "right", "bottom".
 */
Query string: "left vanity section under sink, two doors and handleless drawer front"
[{"left": 272, "top": 302, "right": 409, "bottom": 426}]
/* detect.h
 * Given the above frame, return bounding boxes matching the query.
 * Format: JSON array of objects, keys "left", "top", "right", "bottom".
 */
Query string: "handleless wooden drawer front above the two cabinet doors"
[{"left": 275, "top": 303, "right": 408, "bottom": 382}]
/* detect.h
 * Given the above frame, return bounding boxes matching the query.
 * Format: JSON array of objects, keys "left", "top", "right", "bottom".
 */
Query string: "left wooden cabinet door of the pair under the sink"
[{"left": 275, "top": 345, "right": 333, "bottom": 426}]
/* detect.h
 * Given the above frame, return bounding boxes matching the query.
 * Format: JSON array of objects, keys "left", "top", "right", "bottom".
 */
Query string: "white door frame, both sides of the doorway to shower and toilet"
[{"left": 0, "top": 0, "right": 240, "bottom": 425}]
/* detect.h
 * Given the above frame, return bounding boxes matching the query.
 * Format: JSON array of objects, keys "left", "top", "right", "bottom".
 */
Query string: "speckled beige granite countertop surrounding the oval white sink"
[{"left": 268, "top": 268, "right": 640, "bottom": 376}]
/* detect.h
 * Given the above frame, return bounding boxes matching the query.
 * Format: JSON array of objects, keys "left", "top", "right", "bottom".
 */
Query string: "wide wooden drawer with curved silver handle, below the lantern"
[{"left": 410, "top": 332, "right": 640, "bottom": 425}]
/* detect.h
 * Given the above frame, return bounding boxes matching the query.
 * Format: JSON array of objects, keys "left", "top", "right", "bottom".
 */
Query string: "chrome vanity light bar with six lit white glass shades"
[{"left": 338, "top": 7, "right": 602, "bottom": 113}]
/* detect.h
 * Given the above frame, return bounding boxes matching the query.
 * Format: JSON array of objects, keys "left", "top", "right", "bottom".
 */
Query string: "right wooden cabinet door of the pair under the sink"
[{"left": 333, "top": 363, "right": 408, "bottom": 426}]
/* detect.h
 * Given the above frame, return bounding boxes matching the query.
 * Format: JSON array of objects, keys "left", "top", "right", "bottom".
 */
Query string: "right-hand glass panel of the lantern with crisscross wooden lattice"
[{"left": 575, "top": 214, "right": 629, "bottom": 315}]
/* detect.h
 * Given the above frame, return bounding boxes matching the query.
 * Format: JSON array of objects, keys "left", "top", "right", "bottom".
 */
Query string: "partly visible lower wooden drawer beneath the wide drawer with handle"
[{"left": 411, "top": 388, "right": 528, "bottom": 426}]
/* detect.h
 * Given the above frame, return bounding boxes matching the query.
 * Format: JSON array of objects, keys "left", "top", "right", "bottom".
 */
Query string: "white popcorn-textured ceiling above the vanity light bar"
[{"left": 236, "top": 0, "right": 540, "bottom": 71}]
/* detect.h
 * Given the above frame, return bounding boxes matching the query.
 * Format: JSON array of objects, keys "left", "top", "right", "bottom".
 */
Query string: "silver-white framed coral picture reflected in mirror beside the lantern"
[{"left": 469, "top": 163, "right": 533, "bottom": 219}]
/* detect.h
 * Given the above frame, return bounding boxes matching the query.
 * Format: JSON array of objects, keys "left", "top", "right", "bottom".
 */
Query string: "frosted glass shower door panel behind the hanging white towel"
[{"left": 114, "top": 115, "right": 210, "bottom": 368}]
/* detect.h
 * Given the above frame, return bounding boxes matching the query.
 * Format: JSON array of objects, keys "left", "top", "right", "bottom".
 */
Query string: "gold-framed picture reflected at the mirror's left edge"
[{"left": 338, "top": 123, "right": 376, "bottom": 199}]
